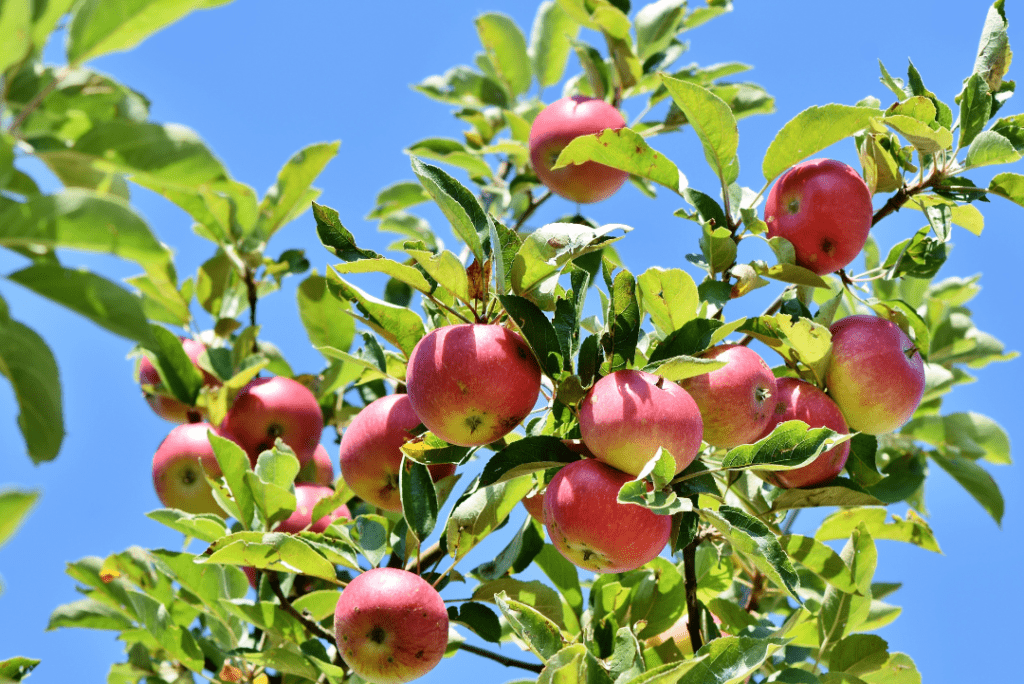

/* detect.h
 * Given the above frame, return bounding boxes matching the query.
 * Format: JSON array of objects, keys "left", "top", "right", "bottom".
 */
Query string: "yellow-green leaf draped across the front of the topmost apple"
[{"left": 552, "top": 128, "right": 689, "bottom": 195}]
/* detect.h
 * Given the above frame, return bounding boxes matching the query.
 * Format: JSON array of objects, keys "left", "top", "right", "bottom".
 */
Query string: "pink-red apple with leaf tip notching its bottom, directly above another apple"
[{"left": 580, "top": 371, "right": 703, "bottom": 475}]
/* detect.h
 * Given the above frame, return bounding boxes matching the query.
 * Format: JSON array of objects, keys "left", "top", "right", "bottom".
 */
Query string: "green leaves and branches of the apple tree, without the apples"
[{"left": 0, "top": 0, "right": 1024, "bottom": 684}]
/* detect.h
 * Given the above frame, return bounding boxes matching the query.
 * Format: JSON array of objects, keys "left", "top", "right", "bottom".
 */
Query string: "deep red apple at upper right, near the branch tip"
[{"left": 765, "top": 159, "right": 873, "bottom": 275}]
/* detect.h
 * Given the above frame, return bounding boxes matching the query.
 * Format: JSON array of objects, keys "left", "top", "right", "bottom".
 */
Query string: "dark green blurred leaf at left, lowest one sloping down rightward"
[{"left": 7, "top": 263, "right": 153, "bottom": 344}]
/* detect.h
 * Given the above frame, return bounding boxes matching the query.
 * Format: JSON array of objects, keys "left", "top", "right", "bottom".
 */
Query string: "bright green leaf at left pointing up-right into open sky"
[{"left": 256, "top": 140, "right": 341, "bottom": 238}]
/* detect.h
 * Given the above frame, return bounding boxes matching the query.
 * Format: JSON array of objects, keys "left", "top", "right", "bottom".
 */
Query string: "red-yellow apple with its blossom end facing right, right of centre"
[{"left": 680, "top": 344, "right": 775, "bottom": 448}]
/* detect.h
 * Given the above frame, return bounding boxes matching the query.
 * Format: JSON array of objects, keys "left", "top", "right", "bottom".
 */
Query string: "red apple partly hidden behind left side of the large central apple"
[{"left": 339, "top": 394, "right": 456, "bottom": 513}]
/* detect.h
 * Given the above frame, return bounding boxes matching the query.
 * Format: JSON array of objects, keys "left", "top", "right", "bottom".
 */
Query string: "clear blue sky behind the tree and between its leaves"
[{"left": 0, "top": 0, "right": 1024, "bottom": 684}]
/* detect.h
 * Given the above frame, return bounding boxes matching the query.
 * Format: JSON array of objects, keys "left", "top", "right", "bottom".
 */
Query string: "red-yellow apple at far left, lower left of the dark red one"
[{"left": 153, "top": 423, "right": 233, "bottom": 517}]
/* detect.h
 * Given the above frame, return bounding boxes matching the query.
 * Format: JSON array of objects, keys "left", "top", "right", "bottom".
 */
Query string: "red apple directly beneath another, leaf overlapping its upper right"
[{"left": 544, "top": 459, "right": 672, "bottom": 572}]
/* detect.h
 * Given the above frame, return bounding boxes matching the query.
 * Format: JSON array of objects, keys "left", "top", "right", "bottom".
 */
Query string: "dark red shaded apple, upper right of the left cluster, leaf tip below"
[{"left": 223, "top": 376, "right": 324, "bottom": 467}]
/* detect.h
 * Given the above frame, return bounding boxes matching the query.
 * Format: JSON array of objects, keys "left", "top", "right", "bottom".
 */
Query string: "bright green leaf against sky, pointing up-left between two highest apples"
[{"left": 662, "top": 75, "right": 739, "bottom": 187}]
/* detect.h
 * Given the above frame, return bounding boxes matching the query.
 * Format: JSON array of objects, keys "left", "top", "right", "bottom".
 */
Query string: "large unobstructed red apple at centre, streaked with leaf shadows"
[{"left": 406, "top": 324, "right": 541, "bottom": 446}]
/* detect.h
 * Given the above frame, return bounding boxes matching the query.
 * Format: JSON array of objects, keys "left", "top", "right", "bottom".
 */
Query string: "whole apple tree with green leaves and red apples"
[{"left": 0, "top": 0, "right": 1024, "bottom": 684}]
